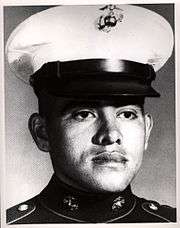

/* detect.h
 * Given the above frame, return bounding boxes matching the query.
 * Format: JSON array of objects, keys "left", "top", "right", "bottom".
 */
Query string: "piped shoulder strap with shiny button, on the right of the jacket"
[{"left": 141, "top": 199, "right": 176, "bottom": 222}]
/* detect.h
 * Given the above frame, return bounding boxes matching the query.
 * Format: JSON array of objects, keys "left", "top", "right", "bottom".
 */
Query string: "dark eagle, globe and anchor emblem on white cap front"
[{"left": 97, "top": 5, "right": 124, "bottom": 32}]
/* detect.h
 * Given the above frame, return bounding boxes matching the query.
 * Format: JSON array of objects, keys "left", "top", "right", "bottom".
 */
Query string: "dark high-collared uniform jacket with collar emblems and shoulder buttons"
[{"left": 7, "top": 175, "right": 176, "bottom": 224}]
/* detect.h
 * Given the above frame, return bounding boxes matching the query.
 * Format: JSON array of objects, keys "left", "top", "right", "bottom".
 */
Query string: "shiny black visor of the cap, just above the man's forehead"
[{"left": 45, "top": 81, "right": 160, "bottom": 99}]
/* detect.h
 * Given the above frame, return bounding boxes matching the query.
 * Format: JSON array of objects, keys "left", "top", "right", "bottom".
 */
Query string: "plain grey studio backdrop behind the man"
[{"left": 0, "top": 0, "right": 178, "bottom": 226}]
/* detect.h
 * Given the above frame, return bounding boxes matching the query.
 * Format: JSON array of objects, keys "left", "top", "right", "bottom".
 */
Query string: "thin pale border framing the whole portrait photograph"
[{"left": 0, "top": 0, "right": 180, "bottom": 228}]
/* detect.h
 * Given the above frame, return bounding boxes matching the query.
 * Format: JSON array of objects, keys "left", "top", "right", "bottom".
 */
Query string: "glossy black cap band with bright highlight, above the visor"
[{"left": 30, "top": 59, "right": 156, "bottom": 81}]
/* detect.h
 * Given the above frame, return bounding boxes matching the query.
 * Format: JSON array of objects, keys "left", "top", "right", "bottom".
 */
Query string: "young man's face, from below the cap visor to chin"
[{"left": 31, "top": 97, "right": 151, "bottom": 192}]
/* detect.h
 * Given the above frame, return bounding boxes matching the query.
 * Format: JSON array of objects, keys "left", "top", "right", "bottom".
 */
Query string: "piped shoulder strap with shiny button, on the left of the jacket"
[{"left": 6, "top": 197, "right": 36, "bottom": 224}]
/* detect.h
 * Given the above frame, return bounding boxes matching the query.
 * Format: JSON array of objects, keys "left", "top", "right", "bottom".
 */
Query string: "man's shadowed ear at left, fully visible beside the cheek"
[{"left": 28, "top": 113, "right": 50, "bottom": 152}]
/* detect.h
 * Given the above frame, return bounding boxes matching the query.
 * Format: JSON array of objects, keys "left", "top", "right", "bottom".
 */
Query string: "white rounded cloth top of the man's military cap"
[{"left": 6, "top": 5, "right": 173, "bottom": 82}]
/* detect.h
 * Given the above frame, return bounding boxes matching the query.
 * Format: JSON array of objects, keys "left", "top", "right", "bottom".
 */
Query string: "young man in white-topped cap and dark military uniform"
[{"left": 6, "top": 5, "right": 176, "bottom": 224}]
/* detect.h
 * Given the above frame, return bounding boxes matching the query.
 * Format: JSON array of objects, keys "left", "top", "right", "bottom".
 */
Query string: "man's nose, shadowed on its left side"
[{"left": 92, "top": 119, "right": 122, "bottom": 146}]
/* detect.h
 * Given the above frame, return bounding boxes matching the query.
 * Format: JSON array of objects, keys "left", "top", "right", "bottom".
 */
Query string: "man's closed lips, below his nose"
[{"left": 92, "top": 151, "right": 128, "bottom": 165}]
